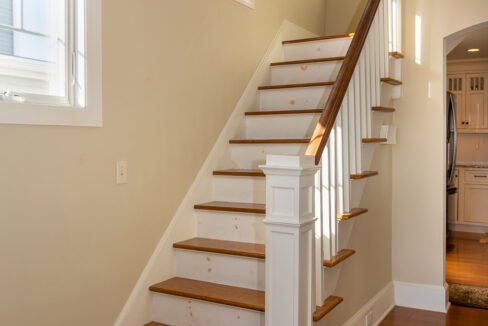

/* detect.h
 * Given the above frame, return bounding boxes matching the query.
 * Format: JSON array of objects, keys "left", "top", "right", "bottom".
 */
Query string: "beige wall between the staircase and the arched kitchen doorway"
[{"left": 393, "top": 0, "right": 488, "bottom": 286}]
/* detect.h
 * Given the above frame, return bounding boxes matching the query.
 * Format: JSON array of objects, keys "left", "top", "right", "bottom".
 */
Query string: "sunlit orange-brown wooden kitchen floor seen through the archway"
[{"left": 446, "top": 233, "right": 488, "bottom": 288}]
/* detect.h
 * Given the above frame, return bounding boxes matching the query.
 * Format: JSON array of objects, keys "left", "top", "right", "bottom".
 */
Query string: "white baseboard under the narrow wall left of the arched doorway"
[{"left": 393, "top": 281, "right": 449, "bottom": 313}]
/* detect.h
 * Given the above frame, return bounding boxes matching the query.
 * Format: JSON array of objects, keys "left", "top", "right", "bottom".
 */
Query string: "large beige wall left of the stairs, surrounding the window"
[{"left": 0, "top": 0, "right": 325, "bottom": 326}]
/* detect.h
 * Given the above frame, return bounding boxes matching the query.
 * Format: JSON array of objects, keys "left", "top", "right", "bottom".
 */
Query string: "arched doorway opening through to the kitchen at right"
[{"left": 445, "top": 22, "right": 488, "bottom": 309}]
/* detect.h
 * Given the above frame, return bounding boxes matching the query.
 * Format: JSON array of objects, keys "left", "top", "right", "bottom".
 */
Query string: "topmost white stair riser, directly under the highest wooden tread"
[{"left": 283, "top": 38, "right": 351, "bottom": 61}]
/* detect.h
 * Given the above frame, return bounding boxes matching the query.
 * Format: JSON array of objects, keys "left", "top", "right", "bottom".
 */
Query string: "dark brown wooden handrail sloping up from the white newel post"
[{"left": 306, "top": 0, "right": 381, "bottom": 164}]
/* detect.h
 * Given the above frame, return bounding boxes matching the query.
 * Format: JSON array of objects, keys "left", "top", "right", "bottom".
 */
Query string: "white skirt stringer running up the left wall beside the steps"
[{"left": 114, "top": 21, "right": 317, "bottom": 326}]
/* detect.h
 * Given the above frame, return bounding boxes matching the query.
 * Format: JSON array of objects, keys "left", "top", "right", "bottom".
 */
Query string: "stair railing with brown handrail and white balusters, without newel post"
[{"left": 306, "top": 0, "right": 402, "bottom": 306}]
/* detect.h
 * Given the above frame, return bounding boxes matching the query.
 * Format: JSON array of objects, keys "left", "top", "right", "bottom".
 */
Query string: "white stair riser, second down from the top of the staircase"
[{"left": 271, "top": 61, "right": 342, "bottom": 85}]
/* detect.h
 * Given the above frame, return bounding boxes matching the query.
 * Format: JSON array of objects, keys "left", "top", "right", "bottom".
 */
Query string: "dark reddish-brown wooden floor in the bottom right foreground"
[{"left": 380, "top": 306, "right": 488, "bottom": 326}]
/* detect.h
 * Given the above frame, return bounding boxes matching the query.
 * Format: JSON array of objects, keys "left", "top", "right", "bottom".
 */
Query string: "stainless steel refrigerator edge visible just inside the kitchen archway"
[{"left": 446, "top": 92, "right": 458, "bottom": 246}]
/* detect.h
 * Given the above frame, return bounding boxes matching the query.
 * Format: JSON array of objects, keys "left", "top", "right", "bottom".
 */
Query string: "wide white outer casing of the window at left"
[{"left": 0, "top": 0, "right": 102, "bottom": 127}]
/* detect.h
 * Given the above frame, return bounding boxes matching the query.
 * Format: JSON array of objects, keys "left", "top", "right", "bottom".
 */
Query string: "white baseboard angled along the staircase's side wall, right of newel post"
[{"left": 344, "top": 283, "right": 395, "bottom": 326}]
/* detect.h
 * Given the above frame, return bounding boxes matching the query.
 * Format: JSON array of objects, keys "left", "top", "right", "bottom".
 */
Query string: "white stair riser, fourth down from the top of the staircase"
[{"left": 246, "top": 114, "right": 320, "bottom": 139}]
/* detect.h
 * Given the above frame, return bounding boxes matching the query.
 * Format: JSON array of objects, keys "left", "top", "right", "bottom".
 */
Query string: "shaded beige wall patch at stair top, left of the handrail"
[{"left": 325, "top": 0, "right": 367, "bottom": 35}]
